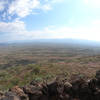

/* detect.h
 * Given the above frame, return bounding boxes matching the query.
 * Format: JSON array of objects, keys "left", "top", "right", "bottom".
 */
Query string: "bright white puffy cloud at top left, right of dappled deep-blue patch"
[{"left": 8, "top": 0, "right": 40, "bottom": 17}]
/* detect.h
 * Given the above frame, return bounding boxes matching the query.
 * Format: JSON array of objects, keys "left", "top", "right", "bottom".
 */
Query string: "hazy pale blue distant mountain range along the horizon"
[{"left": 0, "top": 39, "right": 100, "bottom": 46}]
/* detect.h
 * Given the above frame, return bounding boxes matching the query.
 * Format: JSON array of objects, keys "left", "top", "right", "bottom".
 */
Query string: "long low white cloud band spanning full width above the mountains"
[{"left": 0, "top": 20, "right": 100, "bottom": 41}]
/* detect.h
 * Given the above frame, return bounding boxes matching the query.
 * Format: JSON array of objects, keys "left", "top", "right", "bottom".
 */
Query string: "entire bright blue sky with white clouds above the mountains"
[{"left": 0, "top": 0, "right": 100, "bottom": 42}]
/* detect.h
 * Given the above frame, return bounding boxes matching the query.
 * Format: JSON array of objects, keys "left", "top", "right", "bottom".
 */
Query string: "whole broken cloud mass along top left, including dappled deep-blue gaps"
[{"left": 0, "top": 0, "right": 64, "bottom": 20}]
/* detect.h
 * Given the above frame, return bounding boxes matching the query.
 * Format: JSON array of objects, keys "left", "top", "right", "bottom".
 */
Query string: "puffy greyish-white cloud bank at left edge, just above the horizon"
[{"left": 0, "top": 20, "right": 26, "bottom": 42}]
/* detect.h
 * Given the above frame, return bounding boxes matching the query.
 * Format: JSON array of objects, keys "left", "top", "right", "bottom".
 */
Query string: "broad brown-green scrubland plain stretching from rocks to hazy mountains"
[{"left": 0, "top": 42, "right": 100, "bottom": 90}]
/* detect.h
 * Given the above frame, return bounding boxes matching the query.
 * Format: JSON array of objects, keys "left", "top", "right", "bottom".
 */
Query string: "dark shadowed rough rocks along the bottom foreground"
[{"left": 0, "top": 71, "right": 100, "bottom": 100}]
